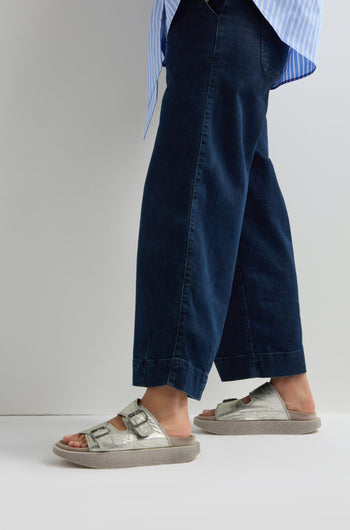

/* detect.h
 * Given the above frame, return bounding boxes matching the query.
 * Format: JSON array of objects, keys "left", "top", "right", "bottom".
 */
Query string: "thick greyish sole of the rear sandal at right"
[{"left": 193, "top": 416, "right": 321, "bottom": 435}]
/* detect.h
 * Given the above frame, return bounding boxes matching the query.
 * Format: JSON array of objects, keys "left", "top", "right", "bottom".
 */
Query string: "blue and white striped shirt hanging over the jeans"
[{"left": 143, "top": 0, "right": 323, "bottom": 139}]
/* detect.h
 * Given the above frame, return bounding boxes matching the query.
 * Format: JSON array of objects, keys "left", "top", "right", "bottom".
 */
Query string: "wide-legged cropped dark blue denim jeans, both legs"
[{"left": 133, "top": 0, "right": 306, "bottom": 400}]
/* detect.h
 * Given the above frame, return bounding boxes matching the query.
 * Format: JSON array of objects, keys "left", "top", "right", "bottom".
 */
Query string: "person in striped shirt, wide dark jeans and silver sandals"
[{"left": 56, "top": 0, "right": 323, "bottom": 467}]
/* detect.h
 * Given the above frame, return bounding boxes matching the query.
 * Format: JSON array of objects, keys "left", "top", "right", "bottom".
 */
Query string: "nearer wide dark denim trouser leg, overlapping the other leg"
[{"left": 133, "top": 0, "right": 278, "bottom": 399}]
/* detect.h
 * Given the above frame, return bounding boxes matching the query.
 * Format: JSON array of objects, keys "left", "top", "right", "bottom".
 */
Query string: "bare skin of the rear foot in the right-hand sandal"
[{"left": 202, "top": 372, "right": 315, "bottom": 416}]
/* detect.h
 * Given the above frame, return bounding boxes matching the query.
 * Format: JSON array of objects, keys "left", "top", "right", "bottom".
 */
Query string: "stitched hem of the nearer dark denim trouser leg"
[{"left": 132, "top": 357, "right": 208, "bottom": 401}]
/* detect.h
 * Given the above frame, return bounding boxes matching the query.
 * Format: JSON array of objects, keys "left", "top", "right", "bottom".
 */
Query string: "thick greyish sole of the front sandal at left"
[{"left": 52, "top": 442, "right": 200, "bottom": 469}]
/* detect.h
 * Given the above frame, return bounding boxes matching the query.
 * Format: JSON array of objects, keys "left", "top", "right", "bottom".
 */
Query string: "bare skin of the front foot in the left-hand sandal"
[{"left": 63, "top": 385, "right": 191, "bottom": 447}]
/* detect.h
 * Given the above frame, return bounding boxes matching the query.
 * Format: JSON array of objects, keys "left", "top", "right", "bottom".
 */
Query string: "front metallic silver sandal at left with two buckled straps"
[{"left": 52, "top": 398, "right": 200, "bottom": 468}]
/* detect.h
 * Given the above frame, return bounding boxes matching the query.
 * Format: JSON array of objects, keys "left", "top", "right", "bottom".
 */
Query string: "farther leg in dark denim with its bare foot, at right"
[{"left": 201, "top": 114, "right": 315, "bottom": 414}]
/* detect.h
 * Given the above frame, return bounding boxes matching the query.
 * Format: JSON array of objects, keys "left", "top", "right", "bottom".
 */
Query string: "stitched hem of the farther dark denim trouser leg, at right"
[{"left": 214, "top": 348, "right": 307, "bottom": 381}]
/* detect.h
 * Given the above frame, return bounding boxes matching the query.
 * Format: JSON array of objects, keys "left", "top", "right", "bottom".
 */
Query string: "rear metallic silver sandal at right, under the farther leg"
[{"left": 193, "top": 382, "right": 321, "bottom": 434}]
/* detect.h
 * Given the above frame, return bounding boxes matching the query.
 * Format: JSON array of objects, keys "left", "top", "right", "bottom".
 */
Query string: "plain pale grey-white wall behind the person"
[{"left": 0, "top": 0, "right": 350, "bottom": 415}]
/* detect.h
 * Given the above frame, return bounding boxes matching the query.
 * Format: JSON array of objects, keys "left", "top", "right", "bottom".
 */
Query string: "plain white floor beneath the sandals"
[{"left": 0, "top": 413, "right": 350, "bottom": 530}]
